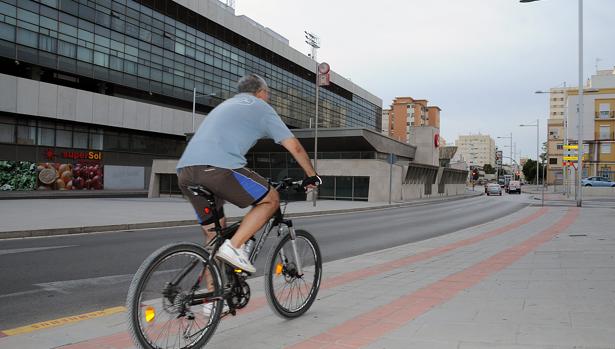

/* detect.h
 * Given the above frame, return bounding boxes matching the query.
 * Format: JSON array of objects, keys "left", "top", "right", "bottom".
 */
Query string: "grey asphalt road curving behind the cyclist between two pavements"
[{"left": 0, "top": 194, "right": 527, "bottom": 330}]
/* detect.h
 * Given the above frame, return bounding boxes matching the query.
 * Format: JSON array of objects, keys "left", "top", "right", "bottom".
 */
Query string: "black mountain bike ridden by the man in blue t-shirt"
[{"left": 126, "top": 178, "right": 322, "bottom": 349}]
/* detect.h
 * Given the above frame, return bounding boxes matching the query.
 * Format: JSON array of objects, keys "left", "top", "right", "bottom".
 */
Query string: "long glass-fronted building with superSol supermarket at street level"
[{"left": 0, "top": 0, "right": 382, "bottom": 190}]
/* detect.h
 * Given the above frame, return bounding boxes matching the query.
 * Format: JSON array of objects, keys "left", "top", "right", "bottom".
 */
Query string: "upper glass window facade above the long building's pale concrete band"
[{"left": 0, "top": 0, "right": 382, "bottom": 131}]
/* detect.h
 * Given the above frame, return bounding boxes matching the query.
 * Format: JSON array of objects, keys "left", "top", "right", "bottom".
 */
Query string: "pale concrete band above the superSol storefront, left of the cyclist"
[{"left": 0, "top": 74, "right": 205, "bottom": 135}]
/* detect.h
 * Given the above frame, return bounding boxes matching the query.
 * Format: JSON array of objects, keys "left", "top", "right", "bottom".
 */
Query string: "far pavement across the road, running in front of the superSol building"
[{"left": 0, "top": 192, "right": 481, "bottom": 239}]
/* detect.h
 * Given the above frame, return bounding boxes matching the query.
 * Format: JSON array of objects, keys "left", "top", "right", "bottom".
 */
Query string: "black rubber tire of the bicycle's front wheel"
[{"left": 264, "top": 230, "right": 322, "bottom": 319}]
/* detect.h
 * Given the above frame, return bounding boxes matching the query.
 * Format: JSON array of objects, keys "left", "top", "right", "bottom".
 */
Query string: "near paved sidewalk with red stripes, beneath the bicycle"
[{"left": 0, "top": 207, "right": 615, "bottom": 349}]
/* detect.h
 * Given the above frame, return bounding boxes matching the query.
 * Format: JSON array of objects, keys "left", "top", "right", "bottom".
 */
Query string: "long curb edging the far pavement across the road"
[{"left": 0, "top": 192, "right": 484, "bottom": 240}]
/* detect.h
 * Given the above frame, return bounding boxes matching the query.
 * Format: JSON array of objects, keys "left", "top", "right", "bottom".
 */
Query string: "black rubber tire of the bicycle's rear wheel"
[{"left": 126, "top": 243, "right": 223, "bottom": 349}]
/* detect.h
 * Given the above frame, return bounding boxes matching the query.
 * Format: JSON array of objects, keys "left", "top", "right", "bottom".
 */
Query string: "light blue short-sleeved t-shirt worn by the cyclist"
[{"left": 177, "top": 93, "right": 294, "bottom": 169}]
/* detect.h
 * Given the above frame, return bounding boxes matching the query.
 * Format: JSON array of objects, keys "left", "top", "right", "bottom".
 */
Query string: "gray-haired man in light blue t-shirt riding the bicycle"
[{"left": 177, "top": 74, "right": 322, "bottom": 273}]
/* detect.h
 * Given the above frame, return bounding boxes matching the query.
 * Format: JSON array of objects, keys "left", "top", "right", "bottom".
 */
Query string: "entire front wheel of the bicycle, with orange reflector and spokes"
[{"left": 265, "top": 230, "right": 322, "bottom": 318}]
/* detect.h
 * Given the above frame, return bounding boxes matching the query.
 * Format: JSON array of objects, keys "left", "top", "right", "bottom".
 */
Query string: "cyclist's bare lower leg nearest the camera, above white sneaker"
[{"left": 231, "top": 188, "right": 280, "bottom": 248}]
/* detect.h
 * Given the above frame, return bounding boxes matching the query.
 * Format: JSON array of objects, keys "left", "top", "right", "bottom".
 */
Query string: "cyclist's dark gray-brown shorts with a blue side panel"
[{"left": 177, "top": 165, "right": 270, "bottom": 224}]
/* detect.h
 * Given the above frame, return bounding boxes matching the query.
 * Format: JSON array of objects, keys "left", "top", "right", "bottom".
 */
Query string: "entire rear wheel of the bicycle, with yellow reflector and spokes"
[{"left": 126, "top": 243, "right": 223, "bottom": 349}]
